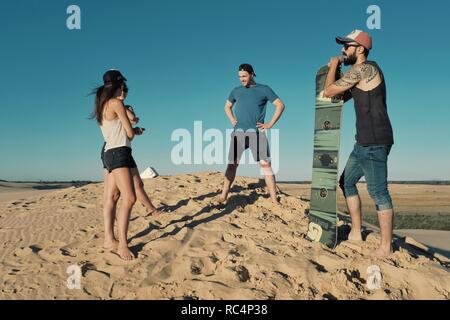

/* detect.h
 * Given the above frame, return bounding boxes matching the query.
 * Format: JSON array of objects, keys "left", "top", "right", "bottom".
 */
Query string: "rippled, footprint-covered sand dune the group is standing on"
[{"left": 0, "top": 173, "right": 450, "bottom": 299}]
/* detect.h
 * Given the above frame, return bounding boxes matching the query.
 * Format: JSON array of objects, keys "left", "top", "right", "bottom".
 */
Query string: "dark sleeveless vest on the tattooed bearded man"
[{"left": 351, "top": 61, "right": 394, "bottom": 146}]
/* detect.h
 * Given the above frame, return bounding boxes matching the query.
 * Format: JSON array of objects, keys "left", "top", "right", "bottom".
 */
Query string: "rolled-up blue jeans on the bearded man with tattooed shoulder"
[{"left": 339, "top": 144, "right": 392, "bottom": 211}]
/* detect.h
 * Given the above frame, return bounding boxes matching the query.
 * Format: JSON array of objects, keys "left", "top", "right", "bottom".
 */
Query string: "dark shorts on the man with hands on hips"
[{"left": 228, "top": 131, "right": 270, "bottom": 164}]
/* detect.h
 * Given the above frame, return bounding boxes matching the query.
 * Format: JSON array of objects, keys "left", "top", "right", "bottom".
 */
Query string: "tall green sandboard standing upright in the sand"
[{"left": 307, "top": 66, "right": 344, "bottom": 248}]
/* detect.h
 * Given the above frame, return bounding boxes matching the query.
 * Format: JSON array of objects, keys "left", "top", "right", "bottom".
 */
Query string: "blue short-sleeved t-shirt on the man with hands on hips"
[{"left": 228, "top": 84, "right": 278, "bottom": 131}]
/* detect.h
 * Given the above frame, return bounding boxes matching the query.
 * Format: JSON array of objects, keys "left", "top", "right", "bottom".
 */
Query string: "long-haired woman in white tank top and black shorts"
[{"left": 92, "top": 70, "right": 149, "bottom": 260}]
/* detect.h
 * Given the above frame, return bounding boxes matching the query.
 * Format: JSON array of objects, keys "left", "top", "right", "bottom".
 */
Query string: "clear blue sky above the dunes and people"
[{"left": 0, "top": 0, "right": 450, "bottom": 180}]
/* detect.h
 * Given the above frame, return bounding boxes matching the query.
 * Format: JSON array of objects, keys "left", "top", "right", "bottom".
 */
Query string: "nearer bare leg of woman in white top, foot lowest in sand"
[{"left": 112, "top": 168, "right": 136, "bottom": 260}]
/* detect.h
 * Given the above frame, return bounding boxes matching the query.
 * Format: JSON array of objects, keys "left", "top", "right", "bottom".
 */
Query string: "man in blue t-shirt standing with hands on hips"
[{"left": 218, "top": 64, "right": 284, "bottom": 204}]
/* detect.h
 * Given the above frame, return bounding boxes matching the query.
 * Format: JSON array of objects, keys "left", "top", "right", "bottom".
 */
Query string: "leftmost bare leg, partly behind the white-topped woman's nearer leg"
[{"left": 103, "top": 169, "right": 120, "bottom": 249}]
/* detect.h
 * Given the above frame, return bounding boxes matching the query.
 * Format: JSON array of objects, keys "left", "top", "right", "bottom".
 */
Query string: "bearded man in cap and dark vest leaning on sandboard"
[{"left": 324, "top": 30, "right": 394, "bottom": 256}]
